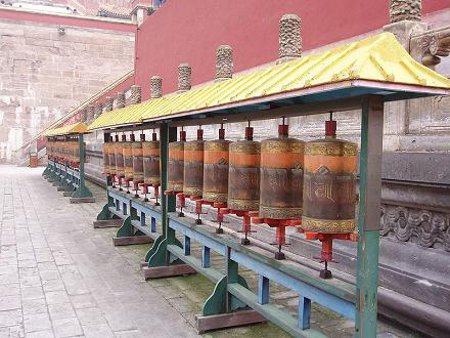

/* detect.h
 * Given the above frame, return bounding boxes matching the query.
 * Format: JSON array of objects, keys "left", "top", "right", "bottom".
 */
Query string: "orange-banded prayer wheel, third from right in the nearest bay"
[{"left": 228, "top": 127, "right": 261, "bottom": 211}]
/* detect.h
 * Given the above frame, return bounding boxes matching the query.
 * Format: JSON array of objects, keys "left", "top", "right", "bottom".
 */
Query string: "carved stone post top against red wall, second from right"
[{"left": 278, "top": 14, "right": 302, "bottom": 63}]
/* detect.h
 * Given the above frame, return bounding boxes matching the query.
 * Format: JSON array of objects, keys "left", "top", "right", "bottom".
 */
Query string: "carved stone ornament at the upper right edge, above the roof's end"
[{"left": 420, "top": 27, "right": 450, "bottom": 68}]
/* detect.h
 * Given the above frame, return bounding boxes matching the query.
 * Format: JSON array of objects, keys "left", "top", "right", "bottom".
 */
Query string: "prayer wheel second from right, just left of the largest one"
[{"left": 259, "top": 124, "right": 304, "bottom": 220}]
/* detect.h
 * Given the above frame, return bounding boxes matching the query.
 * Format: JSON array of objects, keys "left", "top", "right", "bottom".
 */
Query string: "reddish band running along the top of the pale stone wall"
[{"left": 0, "top": 7, "right": 136, "bottom": 32}]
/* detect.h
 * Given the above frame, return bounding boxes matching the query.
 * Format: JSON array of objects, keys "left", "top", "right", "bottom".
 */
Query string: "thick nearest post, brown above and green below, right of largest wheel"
[{"left": 356, "top": 96, "right": 383, "bottom": 338}]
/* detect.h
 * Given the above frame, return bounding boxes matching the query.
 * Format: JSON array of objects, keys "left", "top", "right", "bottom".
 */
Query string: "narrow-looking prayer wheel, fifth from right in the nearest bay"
[{"left": 183, "top": 129, "right": 204, "bottom": 199}]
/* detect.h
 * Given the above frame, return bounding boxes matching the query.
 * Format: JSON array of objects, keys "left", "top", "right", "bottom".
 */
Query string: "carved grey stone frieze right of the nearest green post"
[{"left": 380, "top": 205, "right": 450, "bottom": 251}]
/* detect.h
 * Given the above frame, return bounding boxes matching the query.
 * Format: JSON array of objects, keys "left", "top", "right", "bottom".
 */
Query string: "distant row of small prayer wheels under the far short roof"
[{"left": 46, "top": 139, "right": 80, "bottom": 168}]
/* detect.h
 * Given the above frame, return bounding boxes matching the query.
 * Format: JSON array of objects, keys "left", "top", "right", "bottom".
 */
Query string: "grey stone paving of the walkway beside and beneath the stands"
[{"left": 0, "top": 166, "right": 422, "bottom": 338}]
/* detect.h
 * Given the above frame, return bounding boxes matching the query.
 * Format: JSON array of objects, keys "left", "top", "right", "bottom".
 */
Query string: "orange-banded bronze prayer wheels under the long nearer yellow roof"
[{"left": 105, "top": 119, "right": 358, "bottom": 234}]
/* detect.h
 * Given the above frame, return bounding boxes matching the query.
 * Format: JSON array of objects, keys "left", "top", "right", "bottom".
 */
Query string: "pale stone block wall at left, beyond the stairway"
[{"left": 0, "top": 18, "right": 134, "bottom": 163}]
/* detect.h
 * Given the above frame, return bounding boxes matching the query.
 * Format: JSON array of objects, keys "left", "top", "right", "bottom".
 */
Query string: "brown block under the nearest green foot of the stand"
[{"left": 195, "top": 310, "right": 267, "bottom": 334}]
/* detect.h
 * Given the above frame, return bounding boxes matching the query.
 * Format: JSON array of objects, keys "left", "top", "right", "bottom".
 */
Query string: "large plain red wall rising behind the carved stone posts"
[{"left": 135, "top": 0, "right": 450, "bottom": 99}]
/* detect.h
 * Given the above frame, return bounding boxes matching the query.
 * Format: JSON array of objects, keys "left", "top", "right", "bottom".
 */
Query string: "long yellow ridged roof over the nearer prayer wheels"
[{"left": 88, "top": 33, "right": 450, "bottom": 130}]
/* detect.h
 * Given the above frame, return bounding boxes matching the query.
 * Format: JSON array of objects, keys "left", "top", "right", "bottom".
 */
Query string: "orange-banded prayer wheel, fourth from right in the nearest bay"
[{"left": 203, "top": 128, "right": 230, "bottom": 203}]
